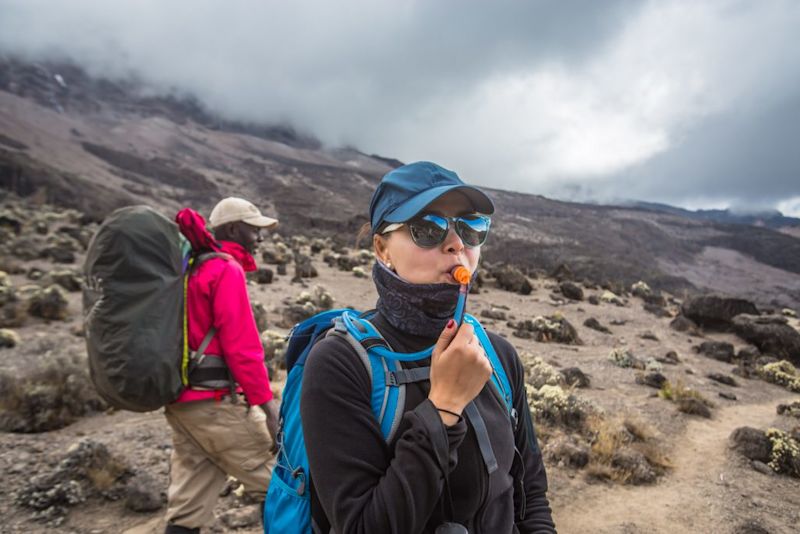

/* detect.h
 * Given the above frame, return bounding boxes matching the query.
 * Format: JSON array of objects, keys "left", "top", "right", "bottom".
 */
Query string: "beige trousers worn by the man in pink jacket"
[{"left": 165, "top": 399, "right": 275, "bottom": 528}]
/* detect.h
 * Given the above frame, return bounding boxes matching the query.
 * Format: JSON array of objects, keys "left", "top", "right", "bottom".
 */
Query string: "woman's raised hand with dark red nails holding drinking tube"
[{"left": 428, "top": 319, "right": 492, "bottom": 425}]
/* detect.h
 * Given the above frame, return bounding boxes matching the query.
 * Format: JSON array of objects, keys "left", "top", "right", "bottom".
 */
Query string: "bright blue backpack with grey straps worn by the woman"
[{"left": 264, "top": 309, "right": 518, "bottom": 534}]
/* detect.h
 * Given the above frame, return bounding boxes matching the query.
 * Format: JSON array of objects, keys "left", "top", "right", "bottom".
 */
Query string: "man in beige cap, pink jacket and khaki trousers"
[{"left": 165, "top": 197, "right": 278, "bottom": 534}]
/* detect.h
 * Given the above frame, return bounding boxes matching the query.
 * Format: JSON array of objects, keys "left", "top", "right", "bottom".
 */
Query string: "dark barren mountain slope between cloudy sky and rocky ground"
[{"left": 0, "top": 57, "right": 800, "bottom": 307}]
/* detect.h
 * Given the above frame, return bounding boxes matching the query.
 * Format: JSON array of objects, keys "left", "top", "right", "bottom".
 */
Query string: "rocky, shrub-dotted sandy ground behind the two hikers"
[{"left": 0, "top": 201, "right": 800, "bottom": 533}]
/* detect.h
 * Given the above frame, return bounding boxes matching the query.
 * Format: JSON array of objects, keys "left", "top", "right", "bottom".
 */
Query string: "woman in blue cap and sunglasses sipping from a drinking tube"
[{"left": 301, "top": 162, "right": 555, "bottom": 534}]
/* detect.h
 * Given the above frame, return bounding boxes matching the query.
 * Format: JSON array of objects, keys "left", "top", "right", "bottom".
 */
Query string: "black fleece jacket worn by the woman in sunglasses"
[{"left": 301, "top": 315, "right": 555, "bottom": 534}]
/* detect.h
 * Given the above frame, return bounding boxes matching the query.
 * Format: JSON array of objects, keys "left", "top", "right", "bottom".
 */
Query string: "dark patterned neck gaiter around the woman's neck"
[{"left": 372, "top": 261, "right": 458, "bottom": 337}]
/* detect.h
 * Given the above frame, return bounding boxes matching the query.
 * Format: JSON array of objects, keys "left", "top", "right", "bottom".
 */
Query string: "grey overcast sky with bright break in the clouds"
[{"left": 0, "top": 0, "right": 800, "bottom": 216}]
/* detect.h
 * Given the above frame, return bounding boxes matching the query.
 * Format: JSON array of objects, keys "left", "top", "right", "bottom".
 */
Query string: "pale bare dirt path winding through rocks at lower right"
[{"left": 555, "top": 397, "right": 797, "bottom": 534}]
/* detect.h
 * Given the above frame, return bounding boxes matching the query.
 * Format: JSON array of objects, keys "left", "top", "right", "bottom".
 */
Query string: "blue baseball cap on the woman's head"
[{"left": 369, "top": 161, "right": 494, "bottom": 232}]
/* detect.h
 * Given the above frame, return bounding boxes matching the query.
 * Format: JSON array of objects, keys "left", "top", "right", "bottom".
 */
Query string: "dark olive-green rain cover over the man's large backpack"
[{"left": 83, "top": 206, "right": 191, "bottom": 412}]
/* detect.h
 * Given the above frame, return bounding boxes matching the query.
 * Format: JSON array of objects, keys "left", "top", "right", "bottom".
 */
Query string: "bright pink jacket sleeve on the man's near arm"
[{"left": 212, "top": 261, "right": 272, "bottom": 405}]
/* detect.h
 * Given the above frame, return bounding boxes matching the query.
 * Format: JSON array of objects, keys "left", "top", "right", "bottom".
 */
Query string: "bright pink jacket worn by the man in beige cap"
[{"left": 176, "top": 241, "right": 272, "bottom": 405}]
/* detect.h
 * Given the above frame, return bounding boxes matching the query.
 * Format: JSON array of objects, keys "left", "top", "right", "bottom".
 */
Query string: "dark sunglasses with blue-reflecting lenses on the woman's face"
[{"left": 381, "top": 213, "right": 492, "bottom": 248}]
